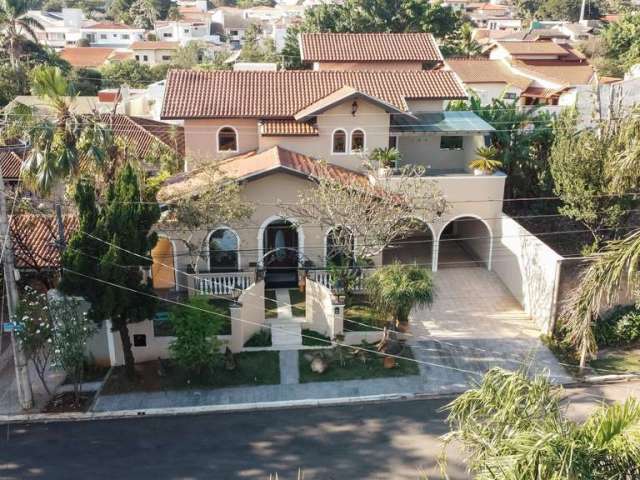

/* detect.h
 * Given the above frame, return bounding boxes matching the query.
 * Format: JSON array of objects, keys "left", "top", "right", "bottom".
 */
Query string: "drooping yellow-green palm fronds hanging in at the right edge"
[{"left": 561, "top": 112, "right": 640, "bottom": 369}]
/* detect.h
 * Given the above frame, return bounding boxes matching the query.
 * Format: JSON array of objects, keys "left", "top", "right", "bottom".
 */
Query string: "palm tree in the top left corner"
[{"left": 0, "top": 0, "right": 43, "bottom": 68}]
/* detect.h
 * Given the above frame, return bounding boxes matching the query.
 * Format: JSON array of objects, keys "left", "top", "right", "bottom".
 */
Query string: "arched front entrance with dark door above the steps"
[{"left": 259, "top": 218, "right": 303, "bottom": 288}]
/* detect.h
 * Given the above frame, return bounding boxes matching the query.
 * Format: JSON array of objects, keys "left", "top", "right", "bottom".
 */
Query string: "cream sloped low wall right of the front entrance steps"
[{"left": 305, "top": 278, "right": 344, "bottom": 339}]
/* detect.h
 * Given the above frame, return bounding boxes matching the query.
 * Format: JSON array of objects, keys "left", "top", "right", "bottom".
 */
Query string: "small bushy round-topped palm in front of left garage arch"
[{"left": 366, "top": 263, "right": 435, "bottom": 326}]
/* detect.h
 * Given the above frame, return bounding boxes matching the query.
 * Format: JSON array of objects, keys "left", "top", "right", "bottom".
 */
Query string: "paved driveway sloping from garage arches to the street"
[{"left": 410, "top": 267, "right": 572, "bottom": 391}]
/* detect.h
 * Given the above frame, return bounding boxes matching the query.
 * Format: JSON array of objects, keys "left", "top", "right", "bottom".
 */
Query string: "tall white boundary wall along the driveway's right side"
[{"left": 493, "top": 214, "right": 562, "bottom": 334}]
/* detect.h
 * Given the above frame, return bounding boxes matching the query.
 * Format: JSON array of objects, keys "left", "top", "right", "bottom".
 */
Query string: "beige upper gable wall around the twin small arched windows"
[{"left": 259, "top": 100, "right": 389, "bottom": 170}]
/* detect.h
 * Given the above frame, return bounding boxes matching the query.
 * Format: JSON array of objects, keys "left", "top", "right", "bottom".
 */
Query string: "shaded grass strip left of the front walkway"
[{"left": 102, "top": 352, "right": 280, "bottom": 395}]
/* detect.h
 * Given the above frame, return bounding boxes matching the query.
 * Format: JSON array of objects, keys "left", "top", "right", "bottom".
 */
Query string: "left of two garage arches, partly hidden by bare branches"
[{"left": 382, "top": 220, "right": 434, "bottom": 268}]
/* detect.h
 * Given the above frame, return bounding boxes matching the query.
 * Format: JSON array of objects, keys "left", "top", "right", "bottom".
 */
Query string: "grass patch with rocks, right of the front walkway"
[{"left": 298, "top": 344, "right": 420, "bottom": 383}]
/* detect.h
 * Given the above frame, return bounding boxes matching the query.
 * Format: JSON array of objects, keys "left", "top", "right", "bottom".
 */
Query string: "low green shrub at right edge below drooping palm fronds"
[{"left": 596, "top": 305, "right": 640, "bottom": 347}]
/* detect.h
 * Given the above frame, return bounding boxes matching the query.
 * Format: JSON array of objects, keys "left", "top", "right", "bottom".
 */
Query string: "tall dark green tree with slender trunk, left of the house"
[{"left": 60, "top": 164, "right": 160, "bottom": 378}]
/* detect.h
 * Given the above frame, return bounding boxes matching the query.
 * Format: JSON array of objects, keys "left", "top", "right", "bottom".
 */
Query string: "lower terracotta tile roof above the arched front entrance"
[{"left": 158, "top": 146, "right": 370, "bottom": 202}]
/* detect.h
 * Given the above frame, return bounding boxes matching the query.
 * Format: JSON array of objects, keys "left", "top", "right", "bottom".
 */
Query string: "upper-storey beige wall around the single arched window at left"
[{"left": 184, "top": 118, "right": 258, "bottom": 170}]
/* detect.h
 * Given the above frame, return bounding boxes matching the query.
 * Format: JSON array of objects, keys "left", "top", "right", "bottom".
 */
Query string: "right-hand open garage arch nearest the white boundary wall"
[{"left": 434, "top": 215, "right": 493, "bottom": 270}]
